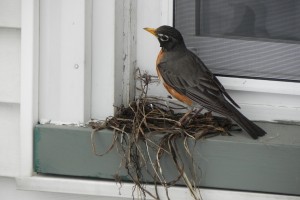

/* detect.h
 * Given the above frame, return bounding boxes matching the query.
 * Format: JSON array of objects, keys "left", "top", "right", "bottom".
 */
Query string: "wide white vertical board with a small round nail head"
[{"left": 39, "top": 0, "right": 92, "bottom": 123}]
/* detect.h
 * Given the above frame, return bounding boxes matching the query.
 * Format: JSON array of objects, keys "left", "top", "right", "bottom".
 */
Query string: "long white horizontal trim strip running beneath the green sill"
[{"left": 16, "top": 176, "right": 300, "bottom": 200}]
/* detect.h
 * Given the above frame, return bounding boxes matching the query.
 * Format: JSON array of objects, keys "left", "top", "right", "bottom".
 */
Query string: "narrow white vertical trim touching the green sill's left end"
[{"left": 19, "top": 0, "right": 39, "bottom": 176}]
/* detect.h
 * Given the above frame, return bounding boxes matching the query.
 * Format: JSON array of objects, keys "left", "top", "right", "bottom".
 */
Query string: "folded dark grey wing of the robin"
[{"left": 158, "top": 51, "right": 239, "bottom": 115}]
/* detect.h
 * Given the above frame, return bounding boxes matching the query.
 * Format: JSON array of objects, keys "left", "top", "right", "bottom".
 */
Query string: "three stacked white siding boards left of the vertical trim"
[{"left": 0, "top": 0, "right": 21, "bottom": 177}]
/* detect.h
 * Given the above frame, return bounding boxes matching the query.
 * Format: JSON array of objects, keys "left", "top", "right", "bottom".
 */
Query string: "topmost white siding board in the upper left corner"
[{"left": 0, "top": 0, "right": 21, "bottom": 28}]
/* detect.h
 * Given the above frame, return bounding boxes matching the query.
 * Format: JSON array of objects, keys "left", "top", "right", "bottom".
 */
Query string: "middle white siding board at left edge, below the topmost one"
[{"left": 0, "top": 27, "right": 21, "bottom": 103}]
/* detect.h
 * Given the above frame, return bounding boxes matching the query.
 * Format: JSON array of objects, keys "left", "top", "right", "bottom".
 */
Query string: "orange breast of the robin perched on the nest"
[{"left": 156, "top": 50, "right": 193, "bottom": 106}]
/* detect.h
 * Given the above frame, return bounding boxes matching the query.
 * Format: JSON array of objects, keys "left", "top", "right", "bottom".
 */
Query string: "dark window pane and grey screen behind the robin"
[{"left": 174, "top": 0, "right": 300, "bottom": 81}]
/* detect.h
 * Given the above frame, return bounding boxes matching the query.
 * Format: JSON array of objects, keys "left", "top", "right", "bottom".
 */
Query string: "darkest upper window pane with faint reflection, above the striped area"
[{"left": 196, "top": 0, "right": 300, "bottom": 41}]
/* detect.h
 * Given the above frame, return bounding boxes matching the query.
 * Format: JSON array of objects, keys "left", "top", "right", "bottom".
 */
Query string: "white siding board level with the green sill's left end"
[{"left": 0, "top": 103, "right": 20, "bottom": 177}]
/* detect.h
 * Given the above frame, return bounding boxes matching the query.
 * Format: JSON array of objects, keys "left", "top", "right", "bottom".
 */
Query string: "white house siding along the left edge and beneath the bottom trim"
[{"left": 0, "top": 0, "right": 115, "bottom": 200}]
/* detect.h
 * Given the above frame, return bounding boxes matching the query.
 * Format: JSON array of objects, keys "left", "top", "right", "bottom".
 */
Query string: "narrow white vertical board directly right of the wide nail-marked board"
[{"left": 91, "top": 0, "right": 116, "bottom": 119}]
